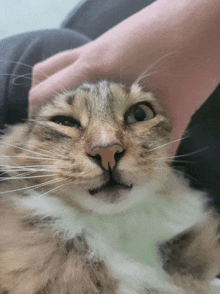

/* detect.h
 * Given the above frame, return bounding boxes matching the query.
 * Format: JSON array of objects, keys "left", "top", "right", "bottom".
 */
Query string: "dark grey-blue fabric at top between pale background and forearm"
[{"left": 62, "top": 0, "right": 155, "bottom": 40}]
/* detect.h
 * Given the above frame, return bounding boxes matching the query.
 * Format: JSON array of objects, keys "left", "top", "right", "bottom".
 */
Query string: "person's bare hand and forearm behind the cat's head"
[{"left": 29, "top": 0, "right": 220, "bottom": 155}]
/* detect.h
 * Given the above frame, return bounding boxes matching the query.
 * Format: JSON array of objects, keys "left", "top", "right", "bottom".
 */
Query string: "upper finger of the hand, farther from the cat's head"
[{"left": 32, "top": 50, "right": 79, "bottom": 87}]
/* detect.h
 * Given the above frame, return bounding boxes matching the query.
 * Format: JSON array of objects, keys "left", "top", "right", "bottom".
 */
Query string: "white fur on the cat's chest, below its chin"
[{"left": 17, "top": 179, "right": 206, "bottom": 294}]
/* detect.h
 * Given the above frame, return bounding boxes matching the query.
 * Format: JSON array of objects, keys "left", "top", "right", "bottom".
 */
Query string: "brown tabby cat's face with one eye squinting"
[{"left": 3, "top": 81, "right": 171, "bottom": 211}]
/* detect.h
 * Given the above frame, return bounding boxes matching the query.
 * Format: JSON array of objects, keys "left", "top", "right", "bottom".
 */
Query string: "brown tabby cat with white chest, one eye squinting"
[{"left": 0, "top": 80, "right": 220, "bottom": 294}]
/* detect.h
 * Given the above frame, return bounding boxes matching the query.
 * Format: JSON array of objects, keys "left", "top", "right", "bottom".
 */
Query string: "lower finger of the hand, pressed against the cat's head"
[{"left": 29, "top": 61, "right": 89, "bottom": 117}]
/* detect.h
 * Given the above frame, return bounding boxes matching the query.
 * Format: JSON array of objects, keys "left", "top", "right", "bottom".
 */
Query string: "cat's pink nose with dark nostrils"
[{"left": 90, "top": 144, "right": 124, "bottom": 170}]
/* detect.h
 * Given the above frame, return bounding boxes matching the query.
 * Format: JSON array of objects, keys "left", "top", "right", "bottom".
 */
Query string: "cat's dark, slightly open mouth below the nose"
[{"left": 89, "top": 179, "right": 133, "bottom": 196}]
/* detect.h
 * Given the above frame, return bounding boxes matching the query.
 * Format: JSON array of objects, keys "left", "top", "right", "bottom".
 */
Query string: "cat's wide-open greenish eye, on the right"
[{"left": 125, "top": 102, "right": 155, "bottom": 124}]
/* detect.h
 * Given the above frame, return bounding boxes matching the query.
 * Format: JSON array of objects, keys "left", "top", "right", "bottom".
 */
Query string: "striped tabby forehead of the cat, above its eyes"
[{"left": 40, "top": 80, "right": 162, "bottom": 119}]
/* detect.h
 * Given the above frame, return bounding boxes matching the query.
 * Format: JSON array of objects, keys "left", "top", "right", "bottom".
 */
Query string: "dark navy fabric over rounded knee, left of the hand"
[{"left": 0, "top": 29, "right": 90, "bottom": 129}]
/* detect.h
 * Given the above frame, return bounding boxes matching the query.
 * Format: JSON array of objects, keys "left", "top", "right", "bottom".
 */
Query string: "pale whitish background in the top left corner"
[{"left": 0, "top": 0, "right": 82, "bottom": 39}]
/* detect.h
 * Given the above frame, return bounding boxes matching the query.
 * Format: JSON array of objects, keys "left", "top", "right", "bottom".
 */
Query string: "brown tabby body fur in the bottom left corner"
[{"left": 0, "top": 201, "right": 118, "bottom": 294}]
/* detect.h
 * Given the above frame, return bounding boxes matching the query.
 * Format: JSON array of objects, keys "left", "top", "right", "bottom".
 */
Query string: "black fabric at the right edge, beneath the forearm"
[{"left": 173, "top": 85, "right": 220, "bottom": 210}]
